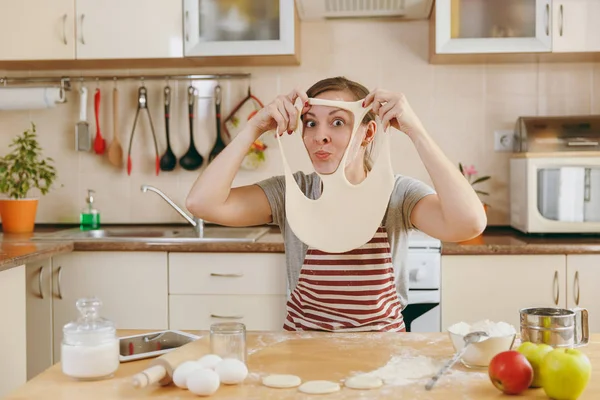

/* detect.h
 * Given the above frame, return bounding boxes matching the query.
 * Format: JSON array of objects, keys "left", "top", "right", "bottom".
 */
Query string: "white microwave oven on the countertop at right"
[{"left": 509, "top": 152, "right": 600, "bottom": 234}]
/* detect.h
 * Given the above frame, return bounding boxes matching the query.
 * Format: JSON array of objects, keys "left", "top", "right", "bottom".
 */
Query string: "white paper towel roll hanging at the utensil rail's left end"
[{"left": 0, "top": 87, "right": 64, "bottom": 110}]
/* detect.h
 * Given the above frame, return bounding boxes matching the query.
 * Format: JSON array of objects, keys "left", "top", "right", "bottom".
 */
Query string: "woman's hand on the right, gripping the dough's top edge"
[{"left": 363, "top": 89, "right": 425, "bottom": 137}]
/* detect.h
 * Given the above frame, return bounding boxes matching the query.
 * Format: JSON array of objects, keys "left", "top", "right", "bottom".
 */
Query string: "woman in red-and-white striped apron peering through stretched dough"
[{"left": 186, "top": 77, "right": 487, "bottom": 332}]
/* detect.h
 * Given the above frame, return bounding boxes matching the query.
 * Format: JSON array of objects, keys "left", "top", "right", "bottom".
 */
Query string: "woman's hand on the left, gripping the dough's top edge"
[{"left": 248, "top": 89, "right": 310, "bottom": 137}]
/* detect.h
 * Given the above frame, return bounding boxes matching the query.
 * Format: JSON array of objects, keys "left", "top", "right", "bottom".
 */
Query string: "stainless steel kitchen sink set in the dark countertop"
[{"left": 33, "top": 225, "right": 269, "bottom": 243}]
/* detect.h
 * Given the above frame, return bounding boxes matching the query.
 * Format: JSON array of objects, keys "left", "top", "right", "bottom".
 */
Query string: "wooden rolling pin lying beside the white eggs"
[{"left": 132, "top": 339, "right": 210, "bottom": 389}]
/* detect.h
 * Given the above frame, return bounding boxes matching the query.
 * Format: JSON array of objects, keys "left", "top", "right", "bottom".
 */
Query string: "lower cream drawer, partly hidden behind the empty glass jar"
[{"left": 169, "top": 295, "right": 286, "bottom": 331}]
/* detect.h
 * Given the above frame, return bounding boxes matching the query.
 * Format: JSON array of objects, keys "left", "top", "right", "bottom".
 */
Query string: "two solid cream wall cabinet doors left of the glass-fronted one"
[{"left": 0, "top": 0, "right": 183, "bottom": 61}]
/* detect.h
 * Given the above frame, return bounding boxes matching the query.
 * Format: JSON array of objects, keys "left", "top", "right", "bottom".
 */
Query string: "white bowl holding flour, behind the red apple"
[{"left": 448, "top": 330, "right": 517, "bottom": 368}]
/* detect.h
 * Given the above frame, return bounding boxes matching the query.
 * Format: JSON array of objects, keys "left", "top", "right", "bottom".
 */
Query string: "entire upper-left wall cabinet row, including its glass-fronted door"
[{"left": 0, "top": 0, "right": 300, "bottom": 70}]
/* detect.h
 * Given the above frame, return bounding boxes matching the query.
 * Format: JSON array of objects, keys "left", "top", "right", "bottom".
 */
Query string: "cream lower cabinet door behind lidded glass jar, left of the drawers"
[{"left": 52, "top": 251, "right": 169, "bottom": 363}]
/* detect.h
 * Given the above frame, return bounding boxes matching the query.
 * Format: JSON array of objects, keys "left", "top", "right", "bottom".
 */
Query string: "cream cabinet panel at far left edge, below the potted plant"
[{"left": 0, "top": 265, "right": 27, "bottom": 398}]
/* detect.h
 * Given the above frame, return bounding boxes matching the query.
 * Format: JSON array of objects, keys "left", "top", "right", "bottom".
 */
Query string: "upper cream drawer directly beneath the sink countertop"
[{"left": 169, "top": 253, "right": 287, "bottom": 295}]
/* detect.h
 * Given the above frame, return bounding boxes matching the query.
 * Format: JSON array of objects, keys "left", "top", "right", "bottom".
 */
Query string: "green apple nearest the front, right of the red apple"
[{"left": 540, "top": 348, "right": 592, "bottom": 400}]
